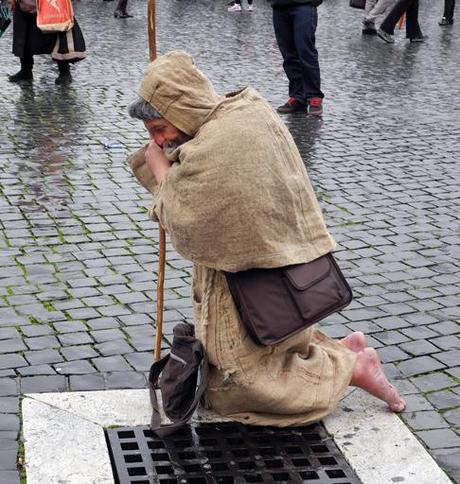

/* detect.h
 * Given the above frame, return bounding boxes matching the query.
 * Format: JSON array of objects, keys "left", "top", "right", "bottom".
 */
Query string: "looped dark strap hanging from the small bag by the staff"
[{"left": 150, "top": 354, "right": 209, "bottom": 438}]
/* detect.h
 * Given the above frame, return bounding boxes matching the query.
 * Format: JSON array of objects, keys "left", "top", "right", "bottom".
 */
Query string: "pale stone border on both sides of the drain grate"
[{"left": 22, "top": 390, "right": 451, "bottom": 484}]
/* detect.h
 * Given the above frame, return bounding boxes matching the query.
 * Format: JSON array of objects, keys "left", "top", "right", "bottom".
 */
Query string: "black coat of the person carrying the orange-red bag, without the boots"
[{"left": 13, "top": 6, "right": 86, "bottom": 62}]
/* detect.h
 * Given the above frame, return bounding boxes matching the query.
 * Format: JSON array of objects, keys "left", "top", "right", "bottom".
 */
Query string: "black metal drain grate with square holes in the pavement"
[{"left": 106, "top": 423, "right": 360, "bottom": 484}]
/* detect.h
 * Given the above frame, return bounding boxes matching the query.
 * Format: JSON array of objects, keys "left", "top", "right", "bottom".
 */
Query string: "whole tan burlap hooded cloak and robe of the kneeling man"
[{"left": 129, "top": 51, "right": 355, "bottom": 426}]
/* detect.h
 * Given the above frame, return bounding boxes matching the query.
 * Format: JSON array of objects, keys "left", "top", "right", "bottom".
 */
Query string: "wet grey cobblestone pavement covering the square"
[{"left": 0, "top": 0, "right": 460, "bottom": 484}]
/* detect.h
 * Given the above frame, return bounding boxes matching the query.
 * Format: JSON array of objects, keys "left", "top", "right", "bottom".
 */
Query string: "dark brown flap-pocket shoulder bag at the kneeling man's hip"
[{"left": 224, "top": 253, "right": 353, "bottom": 346}]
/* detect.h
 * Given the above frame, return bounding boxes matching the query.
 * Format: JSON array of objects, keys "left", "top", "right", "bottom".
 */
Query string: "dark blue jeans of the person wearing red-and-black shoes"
[{"left": 273, "top": 4, "right": 324, "bottom": 103}]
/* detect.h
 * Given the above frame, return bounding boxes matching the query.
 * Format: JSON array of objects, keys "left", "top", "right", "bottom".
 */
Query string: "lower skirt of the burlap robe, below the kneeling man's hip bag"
[{"left": 193, "top": 264, "right": 356, "bottom": 427}]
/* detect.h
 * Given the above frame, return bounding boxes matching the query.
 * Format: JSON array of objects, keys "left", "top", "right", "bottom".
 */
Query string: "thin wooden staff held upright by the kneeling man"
[{"left": 147, "top": 0, "right": 166, "bottom": 361}]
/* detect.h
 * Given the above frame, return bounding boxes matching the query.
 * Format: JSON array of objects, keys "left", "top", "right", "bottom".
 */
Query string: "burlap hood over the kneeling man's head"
[{"left": 139, "top": 50, "right": 223, "bottom": 136}]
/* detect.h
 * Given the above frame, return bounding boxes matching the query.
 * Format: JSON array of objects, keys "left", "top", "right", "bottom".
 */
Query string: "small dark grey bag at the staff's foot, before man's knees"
[{"left": 149, "top": 323, "right": 209, "bottom": 437}]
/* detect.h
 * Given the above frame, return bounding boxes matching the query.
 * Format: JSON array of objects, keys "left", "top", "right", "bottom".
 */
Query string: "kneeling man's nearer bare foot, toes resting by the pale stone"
[{"left": 350, "top": 348, "right": 406, "bottom": 412}]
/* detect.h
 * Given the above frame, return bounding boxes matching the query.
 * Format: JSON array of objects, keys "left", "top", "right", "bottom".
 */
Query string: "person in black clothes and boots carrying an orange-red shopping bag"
[{"left": 8, "top": 0, "right": 86, "bottom": 84}]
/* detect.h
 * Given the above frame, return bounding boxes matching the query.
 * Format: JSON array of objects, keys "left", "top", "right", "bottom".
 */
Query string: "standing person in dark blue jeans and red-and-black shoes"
[{"left": 268, "top": 0, "right": 324, "bottom": 116}]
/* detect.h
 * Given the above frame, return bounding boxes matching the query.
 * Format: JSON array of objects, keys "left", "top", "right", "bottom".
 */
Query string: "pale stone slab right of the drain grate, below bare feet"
[{"left": 324, "top": 389, "right": 452, "bottom": 484}]
